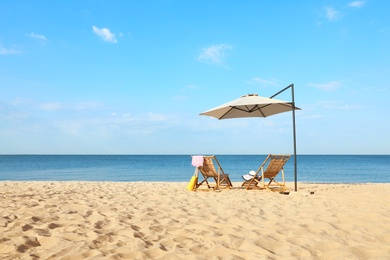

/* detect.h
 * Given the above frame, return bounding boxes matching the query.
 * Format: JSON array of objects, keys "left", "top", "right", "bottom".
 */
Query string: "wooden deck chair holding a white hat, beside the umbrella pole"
[{"left": 241, "top": 154, "right": 291, "bottom": 191}]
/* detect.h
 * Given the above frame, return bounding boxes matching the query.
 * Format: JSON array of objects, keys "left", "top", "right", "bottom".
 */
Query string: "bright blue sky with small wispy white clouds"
[{"left": 0, "top": 0, "right": 390, "bottom": 154}]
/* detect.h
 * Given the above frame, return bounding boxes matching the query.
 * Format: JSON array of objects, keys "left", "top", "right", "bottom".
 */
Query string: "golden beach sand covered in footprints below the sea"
[{"left": 0, "top": 181, "right": 390, "bottom": 259}]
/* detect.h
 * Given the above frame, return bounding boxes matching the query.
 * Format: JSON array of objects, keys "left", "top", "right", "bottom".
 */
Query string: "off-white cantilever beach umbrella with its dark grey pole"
[{"left": 200, "top": 84, "right": 300, "bottom": 191}]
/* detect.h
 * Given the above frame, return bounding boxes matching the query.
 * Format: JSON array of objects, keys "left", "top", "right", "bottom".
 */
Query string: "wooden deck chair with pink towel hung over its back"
[{"left": 195, "top": 155, "right": 233, "bottom": 190}]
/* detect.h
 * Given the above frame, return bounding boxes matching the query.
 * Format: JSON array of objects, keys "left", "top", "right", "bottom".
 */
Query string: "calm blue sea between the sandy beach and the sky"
[{"left": 0, "top": 155, "right": 390, "bottom": 183}]
